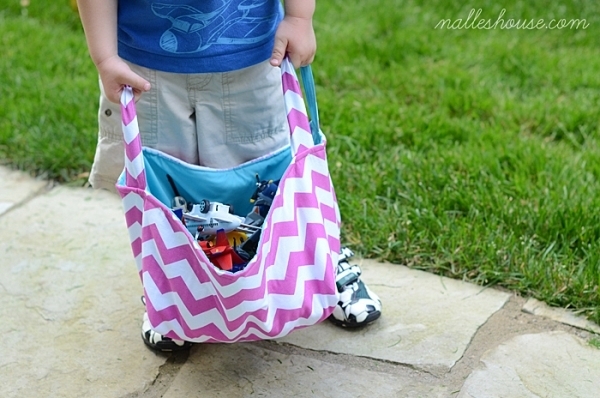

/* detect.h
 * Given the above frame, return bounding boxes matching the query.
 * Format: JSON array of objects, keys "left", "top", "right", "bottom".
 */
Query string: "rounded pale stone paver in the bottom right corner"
[{"left": 458, "top": 332, "right": 600, "bottom": 398}]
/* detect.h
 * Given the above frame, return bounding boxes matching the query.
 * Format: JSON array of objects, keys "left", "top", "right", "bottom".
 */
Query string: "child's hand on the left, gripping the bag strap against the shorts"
[{"left": 96, "top": 56, "right": 150, "bottom": 103}]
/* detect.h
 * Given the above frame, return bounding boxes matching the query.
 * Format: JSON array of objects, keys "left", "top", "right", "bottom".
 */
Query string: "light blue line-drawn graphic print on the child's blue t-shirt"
[{"left": 152, "top": 0, "right": 275, "bottom": 54}]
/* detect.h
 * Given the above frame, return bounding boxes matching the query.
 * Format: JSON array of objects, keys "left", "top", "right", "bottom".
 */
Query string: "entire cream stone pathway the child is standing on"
[{"left": 0, "top": 168, "right": 600, "bottom": 398}]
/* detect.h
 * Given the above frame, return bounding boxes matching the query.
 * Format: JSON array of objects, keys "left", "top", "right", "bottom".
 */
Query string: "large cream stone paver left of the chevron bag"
[{"left": 0, "top": 188, "right": 165, "bottom": 398}]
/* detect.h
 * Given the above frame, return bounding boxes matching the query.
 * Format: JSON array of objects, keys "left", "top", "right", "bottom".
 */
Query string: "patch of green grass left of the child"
[{"left": 0, "top": 0, "right": 98, "bottom": 184}]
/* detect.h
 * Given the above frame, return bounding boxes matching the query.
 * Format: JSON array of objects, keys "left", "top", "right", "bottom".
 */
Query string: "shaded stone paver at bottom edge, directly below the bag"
[{"left": 164, "top": 343, "right": 449, "bottom": 398}]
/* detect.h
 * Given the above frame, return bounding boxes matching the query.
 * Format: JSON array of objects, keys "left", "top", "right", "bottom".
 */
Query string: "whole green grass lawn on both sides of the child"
[{"left": 0, "top": 0, "right": 600, "bottom": 323}]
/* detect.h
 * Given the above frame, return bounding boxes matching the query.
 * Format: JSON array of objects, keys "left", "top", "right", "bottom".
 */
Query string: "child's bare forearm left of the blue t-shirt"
[{"left": 77, "top": 0, "right": 118, "bottom": 66}]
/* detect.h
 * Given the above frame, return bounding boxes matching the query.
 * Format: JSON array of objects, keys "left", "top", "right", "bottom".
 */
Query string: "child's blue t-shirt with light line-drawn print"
[{"left": 118, "top": 0, "right": 283, "bottom": 73}]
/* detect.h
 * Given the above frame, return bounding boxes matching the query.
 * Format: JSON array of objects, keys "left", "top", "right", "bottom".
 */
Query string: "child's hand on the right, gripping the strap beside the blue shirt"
[{"left": 271, "top": 16, "right": 317, "bottom": 68}]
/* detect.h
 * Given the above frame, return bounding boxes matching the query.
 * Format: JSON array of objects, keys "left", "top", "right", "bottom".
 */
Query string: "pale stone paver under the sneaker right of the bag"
[{"left": 281, "top": 260, "right": 509, "bottom": 374}]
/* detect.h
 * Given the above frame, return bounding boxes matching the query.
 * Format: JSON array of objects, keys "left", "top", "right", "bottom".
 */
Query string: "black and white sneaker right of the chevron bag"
[{"left": 329, "top": 247, "right": 381, "bottom": 328}]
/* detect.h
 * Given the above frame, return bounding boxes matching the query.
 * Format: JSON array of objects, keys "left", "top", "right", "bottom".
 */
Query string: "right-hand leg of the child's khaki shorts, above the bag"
[{"left": 188, "top": 61, "right": 290, "bottom": 168}]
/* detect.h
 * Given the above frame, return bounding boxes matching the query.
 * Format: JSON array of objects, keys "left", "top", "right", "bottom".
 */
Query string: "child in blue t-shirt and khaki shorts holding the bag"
[{"left": 78, "top": 0, "right": 381, "bottom": 351}]
